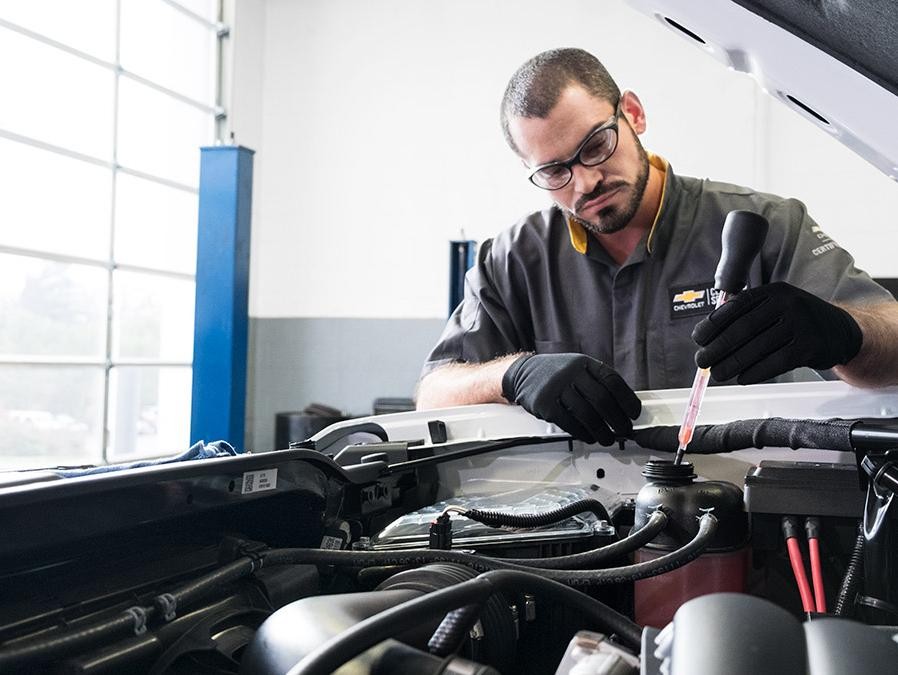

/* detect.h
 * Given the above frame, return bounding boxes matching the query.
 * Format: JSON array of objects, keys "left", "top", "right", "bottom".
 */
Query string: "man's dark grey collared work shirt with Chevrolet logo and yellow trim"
[{"left": 423, "top": 157, "right": 892, "bottom": 389}]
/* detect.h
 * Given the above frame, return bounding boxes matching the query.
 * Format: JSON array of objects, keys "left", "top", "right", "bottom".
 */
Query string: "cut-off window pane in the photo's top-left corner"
[{"left": 0, "top": 0, "right": 115, "bottom": 61}]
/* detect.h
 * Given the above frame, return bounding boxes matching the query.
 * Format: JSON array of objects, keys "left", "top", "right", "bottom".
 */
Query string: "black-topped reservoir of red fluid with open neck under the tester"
[{"left": 633, "top": 460, "right": 749, "bottom": 628}]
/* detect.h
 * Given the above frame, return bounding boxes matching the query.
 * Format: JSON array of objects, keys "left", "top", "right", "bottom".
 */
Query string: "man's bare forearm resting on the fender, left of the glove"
[{"left": 416, "top": 354, "right": 521, "bottom": 410}]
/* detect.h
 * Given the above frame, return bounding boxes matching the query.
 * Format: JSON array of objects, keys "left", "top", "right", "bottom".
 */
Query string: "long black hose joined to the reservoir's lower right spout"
[{"left": 265, "top": 513, "right": 717, "bottom": 586}]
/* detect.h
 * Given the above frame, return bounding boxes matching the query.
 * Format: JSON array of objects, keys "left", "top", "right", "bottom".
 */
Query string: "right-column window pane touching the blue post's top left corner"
[{"left": 118, "top": 77, "right": 214, "bottom": 187}]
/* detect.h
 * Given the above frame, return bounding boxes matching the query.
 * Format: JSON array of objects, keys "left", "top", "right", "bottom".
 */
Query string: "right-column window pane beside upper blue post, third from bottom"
[{"left": 115, "top": 173, "right": 199, "bottom": 274}]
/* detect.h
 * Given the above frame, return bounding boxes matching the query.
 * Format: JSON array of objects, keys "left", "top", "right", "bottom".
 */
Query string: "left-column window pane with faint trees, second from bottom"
[{"left": 0, "top": 254, "right": 108, "bottom": 358}]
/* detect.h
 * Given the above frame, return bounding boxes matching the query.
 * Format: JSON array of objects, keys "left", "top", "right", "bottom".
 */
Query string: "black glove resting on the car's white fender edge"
[{"left": 502, "top": 354, "right": 642, "bottom": 445}]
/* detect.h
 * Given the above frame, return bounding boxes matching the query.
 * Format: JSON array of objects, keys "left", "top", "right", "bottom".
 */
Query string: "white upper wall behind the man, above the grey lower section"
[{"left": 232, "top": 0, "right": 898, "bottom": 318}]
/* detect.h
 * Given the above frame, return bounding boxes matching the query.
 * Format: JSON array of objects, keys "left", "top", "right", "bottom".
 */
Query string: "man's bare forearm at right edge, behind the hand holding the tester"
[{"left": 833, "top": 302, "right": 898, "bottom": 387}]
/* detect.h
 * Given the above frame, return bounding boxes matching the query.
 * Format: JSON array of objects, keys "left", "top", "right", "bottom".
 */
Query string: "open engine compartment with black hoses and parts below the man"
[{"left": 0, "top": 388, "right": 898, "bottom": 674}]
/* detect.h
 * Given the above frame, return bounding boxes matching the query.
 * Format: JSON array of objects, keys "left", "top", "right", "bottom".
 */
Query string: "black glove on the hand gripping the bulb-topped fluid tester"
[{"left": 692, "top": 282, "right": 863, "bottom": 384}]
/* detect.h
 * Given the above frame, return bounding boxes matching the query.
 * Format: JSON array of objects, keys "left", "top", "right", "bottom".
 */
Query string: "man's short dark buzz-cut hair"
[{"left": 501, "top": 48, "right": 620, "bottom": 154}]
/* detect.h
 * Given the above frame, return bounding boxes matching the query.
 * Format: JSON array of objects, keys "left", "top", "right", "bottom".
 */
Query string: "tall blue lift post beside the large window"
[{"left": 190, "top": 146, "right": 253, "bottom": 449}]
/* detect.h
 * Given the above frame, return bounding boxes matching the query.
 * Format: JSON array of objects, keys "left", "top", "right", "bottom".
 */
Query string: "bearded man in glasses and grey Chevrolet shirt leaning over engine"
[{"left": 418, "top": 49, "right": 898, "bottom": 445}]
